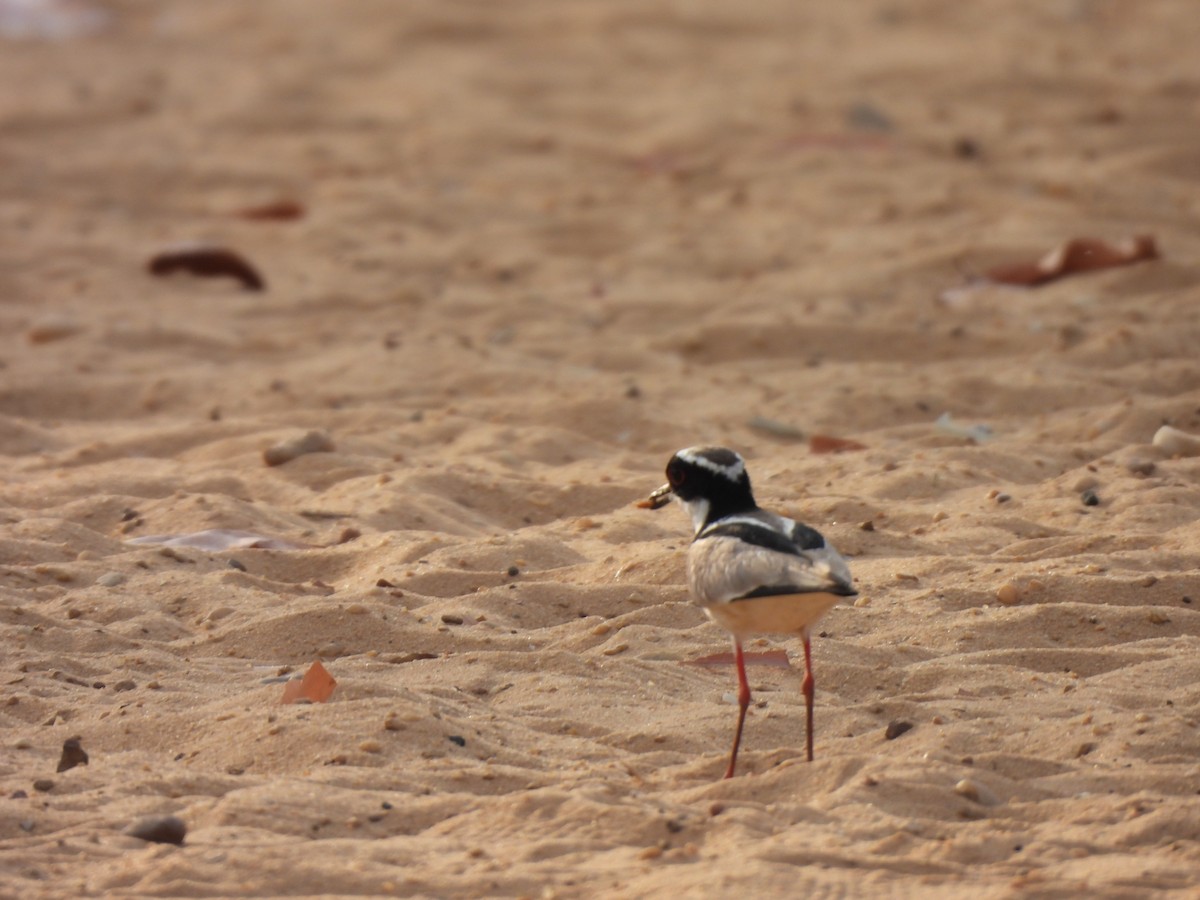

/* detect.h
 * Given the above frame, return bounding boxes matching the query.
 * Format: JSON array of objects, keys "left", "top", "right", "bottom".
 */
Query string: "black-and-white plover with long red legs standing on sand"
[{"left": 637, "top": 446, "right": 858, "bottom": 778}]
